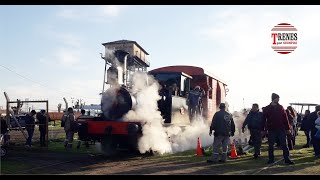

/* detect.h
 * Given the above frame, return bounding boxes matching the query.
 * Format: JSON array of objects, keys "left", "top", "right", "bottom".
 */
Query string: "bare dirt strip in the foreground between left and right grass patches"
[{"left": 1, "top": 152, "right": 210, "bottom": 175}]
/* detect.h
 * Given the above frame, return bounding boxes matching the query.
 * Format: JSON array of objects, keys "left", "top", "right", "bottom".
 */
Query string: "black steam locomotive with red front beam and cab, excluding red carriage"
[{"left": 78, "top": 50, "right": 192, "bottom": 155}]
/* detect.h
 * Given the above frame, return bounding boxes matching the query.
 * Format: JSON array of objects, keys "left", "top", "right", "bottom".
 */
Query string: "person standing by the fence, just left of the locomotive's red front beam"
[{"left": 63, "top": 107, "right": 78, "bottom": 149}]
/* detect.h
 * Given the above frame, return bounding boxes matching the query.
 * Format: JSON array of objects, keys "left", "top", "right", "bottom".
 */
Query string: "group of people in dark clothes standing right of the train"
[{"left": 207, "top": 93, "right": 320, "bottom": 164}]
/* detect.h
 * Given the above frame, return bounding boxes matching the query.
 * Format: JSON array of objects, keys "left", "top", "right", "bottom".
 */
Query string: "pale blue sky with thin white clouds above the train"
[{"left": 0, "top": 6, "right": 320, "bottom": 110}]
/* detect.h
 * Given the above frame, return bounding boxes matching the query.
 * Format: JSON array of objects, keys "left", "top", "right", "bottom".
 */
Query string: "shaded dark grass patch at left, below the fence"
[{"left": 1, "top": 136, "right": 99, "bottom": 174}]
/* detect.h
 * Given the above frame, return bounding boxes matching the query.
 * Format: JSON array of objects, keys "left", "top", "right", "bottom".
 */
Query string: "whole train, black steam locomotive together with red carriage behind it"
[{"left": 78, "top": 42, "right": 227, "bottom": 156}]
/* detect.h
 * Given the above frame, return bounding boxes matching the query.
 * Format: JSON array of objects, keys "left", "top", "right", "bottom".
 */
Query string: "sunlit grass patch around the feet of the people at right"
[{"left": 149, "top": 131, "right": 320, "bottom": 174}]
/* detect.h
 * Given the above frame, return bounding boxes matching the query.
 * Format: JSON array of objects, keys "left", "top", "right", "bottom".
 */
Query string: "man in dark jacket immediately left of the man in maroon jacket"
[{"left": 242, "top": 104, "right": 263, "bottom": 159}]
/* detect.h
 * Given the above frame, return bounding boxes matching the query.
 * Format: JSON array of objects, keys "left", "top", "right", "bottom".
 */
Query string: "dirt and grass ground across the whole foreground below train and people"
[{"left": 1, "top": 133, "right": 320, "bottom": 175}]
